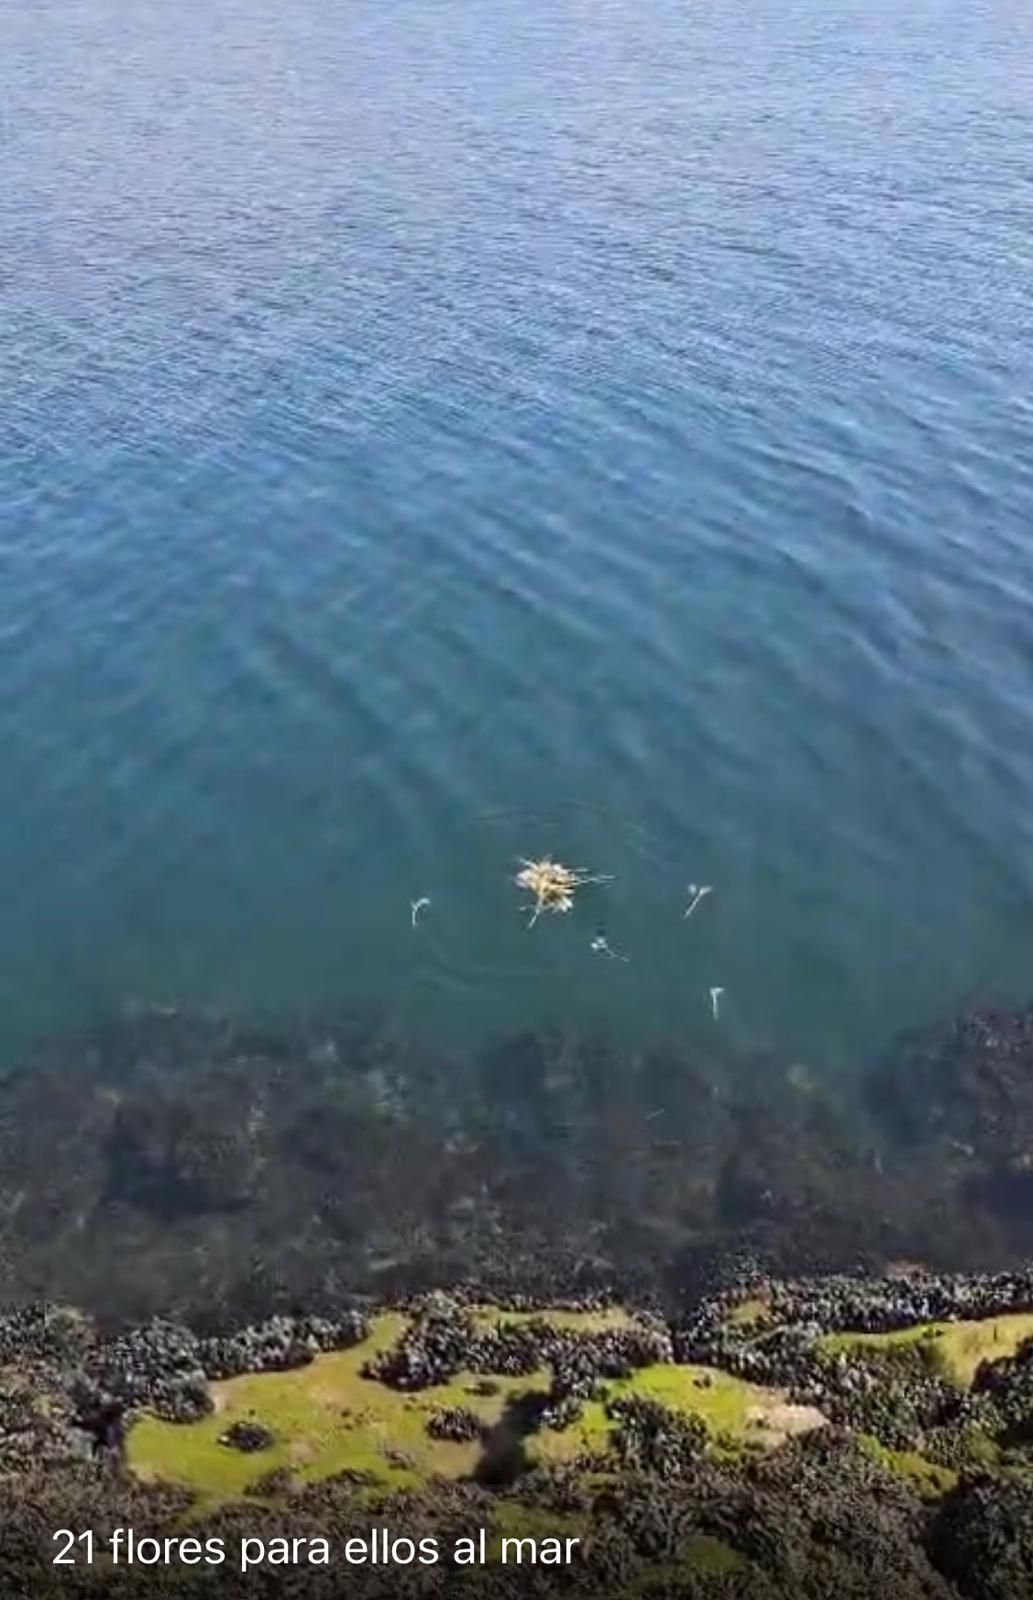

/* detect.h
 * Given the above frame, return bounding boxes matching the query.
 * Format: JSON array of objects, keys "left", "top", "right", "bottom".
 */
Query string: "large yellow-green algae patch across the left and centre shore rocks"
[{"left": 128, "top": 1304, "right": 825, "bottom": 1504}]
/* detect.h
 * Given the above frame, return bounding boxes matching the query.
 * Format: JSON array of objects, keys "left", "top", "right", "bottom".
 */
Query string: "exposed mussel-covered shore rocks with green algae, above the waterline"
[{"left": 14, "top": 1274, "right": 1033, "bottom": 1600}]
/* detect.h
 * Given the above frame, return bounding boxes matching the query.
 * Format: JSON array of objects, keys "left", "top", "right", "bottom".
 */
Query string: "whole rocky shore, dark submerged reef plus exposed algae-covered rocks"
[{"left": 0, "top": 1011, "right": 1033, "bottom": 1600}]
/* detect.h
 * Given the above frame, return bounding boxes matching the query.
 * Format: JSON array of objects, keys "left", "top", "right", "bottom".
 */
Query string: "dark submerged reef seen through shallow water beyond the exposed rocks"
[{"left": 0, "top": 1008, "right": 1033, "bottom": 1325}]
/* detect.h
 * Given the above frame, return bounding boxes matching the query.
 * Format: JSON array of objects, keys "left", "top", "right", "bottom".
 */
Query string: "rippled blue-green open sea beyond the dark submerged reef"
[{"left": 0, "top": 0, "right": 1033, "bottom": 1074}]
